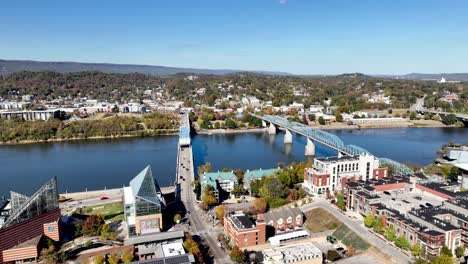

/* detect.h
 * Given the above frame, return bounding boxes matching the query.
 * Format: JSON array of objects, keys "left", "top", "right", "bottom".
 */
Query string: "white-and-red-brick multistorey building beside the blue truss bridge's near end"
[{"left": 303, "top": 153, "right": 388, "bottom": 195}]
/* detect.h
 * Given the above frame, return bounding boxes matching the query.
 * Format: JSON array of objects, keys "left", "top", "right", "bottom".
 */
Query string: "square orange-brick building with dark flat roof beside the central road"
[{"left": 224, "top": 213, "right": 266, "bottom": 248}]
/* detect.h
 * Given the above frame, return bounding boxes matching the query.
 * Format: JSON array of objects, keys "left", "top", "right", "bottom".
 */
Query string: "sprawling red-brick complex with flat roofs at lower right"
[{"left": 345, "top": 177, "right": 468, "bottom": 258}]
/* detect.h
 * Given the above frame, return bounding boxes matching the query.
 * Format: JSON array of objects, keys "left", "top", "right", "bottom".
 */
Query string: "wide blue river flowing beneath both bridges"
[{"left": 0, "top": 128, "right": 468, "bottom": 197}]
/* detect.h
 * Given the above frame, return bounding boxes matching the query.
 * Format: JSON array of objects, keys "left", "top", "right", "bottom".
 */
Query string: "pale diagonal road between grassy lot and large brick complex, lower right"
[{"left": 301, "top": 199, "right": 412, "bottom": 263}]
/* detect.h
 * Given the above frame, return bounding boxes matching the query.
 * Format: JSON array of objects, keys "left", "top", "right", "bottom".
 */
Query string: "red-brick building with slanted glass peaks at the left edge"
[{"left": 0, "top": 178, "right": 61, "bottom": 263}]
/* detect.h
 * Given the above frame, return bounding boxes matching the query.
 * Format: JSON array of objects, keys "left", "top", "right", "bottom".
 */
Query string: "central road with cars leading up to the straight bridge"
[{"left": 177, "top": 147, "right": 233, "bottom": 264}]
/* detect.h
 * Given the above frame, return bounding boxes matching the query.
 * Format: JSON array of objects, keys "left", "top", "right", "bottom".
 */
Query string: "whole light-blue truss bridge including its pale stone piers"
[{"left": 250, "top": 114, "right": 414, "bottom": 175}]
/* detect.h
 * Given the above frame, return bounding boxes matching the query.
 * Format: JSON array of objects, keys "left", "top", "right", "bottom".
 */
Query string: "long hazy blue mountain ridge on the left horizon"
[{"left": 0, "top": 60, "right": 292, "bottom": 76}]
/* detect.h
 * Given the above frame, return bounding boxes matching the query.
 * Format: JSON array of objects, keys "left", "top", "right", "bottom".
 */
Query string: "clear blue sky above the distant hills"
[{"left": 0, "top": 0, "right": 468, "bottom": 74}]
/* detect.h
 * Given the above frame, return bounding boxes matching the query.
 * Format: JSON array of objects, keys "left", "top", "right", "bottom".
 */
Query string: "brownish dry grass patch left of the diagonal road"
[{"left": 305, "top": 208, "right": 341, "bottom": 233}]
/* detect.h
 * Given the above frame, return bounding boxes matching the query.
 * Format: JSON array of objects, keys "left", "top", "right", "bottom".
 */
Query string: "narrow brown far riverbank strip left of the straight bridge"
[{"left": 0, "top": 130, "right": 178, "bottom": 146}]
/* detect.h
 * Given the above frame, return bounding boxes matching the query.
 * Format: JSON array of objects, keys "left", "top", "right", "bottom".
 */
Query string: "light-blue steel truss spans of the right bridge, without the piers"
[{"left": 250, "top": 114, "right": 414, "bottom": 175}]
